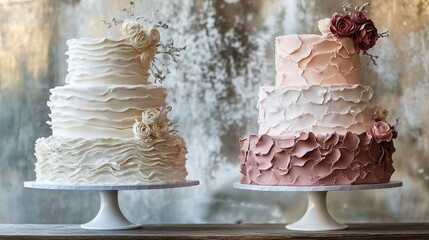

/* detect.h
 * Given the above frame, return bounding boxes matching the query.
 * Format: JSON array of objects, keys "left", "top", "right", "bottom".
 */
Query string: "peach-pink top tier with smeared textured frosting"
[{"left": 275, "top": 34, "right": 360, "bottom": 86}]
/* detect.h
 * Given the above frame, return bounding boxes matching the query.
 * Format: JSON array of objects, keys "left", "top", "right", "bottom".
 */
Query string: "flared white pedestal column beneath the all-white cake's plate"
[{"left": 81, "top": 190, "right": 141, "bottom": 230}]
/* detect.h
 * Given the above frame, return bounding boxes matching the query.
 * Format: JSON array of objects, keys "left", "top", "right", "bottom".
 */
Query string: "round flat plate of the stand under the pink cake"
[{"left": 233, "top": 181, "right": 402, "bottom": 192}]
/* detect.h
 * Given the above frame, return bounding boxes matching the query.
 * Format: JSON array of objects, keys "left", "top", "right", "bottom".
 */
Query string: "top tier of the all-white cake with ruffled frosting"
[{"left": 66, "top": 36, "right": 156, "bottom": 86}]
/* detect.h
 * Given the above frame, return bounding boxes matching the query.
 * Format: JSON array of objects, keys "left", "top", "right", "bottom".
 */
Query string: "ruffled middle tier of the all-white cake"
[{"left": 48, "top": 85, "right": 166, "bottom": 138}]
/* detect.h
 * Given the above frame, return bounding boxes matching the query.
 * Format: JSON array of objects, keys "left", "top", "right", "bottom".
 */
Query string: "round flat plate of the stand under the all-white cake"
[{"left": 24, "top": 180, "right": 200, "bottom": 191}]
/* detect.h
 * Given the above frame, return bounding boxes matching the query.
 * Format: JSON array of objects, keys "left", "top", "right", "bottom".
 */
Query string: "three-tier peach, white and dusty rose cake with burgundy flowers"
[{"left": 239, "top": 6, "right": 397, "bottom": 186}]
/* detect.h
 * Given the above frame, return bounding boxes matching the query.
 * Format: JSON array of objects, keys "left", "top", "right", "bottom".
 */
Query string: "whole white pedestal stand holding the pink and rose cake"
[{"left": 233, "top": 181, "right": 402, "bottom": 231}]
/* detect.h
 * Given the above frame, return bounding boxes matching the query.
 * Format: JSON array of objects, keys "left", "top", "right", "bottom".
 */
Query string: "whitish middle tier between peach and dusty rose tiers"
[{"left": 257, "top": 84, "right": 375, "bottom": 136}]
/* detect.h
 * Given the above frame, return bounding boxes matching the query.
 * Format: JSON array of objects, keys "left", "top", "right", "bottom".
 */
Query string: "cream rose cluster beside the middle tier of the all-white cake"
[{"left": 133, "top": 107, "right": 171, "bottom": 140}]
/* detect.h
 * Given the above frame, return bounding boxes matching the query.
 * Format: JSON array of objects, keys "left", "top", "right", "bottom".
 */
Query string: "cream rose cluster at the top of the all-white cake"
[{"left": 121, "top": 19, "right": 160, "bottom": 67}]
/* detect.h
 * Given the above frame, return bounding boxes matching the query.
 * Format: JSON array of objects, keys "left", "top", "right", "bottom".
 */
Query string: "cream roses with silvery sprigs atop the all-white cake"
[{"left": 102, "top": 1, "right": 186, "bottom": 83}]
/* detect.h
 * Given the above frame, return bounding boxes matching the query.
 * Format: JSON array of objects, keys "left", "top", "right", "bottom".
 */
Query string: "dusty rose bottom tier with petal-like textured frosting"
[{"left": 240, "top": 132, "right": 395, "bottom": 186}]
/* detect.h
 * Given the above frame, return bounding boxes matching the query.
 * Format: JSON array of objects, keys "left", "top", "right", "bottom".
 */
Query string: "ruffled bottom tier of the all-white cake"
[{"left": 35, "top": 135, "right": 187, "bottom": 184}]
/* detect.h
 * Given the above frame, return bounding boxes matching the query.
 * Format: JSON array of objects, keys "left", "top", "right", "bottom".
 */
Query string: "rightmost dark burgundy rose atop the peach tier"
[{"left": 354, "top": 19, "right": 379, "bottom": 51}]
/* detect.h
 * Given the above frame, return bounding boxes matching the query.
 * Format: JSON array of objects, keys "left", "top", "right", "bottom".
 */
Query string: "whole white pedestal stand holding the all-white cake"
[{"left": 24, "top": 180, "right": 199, "bottom": 230}]
